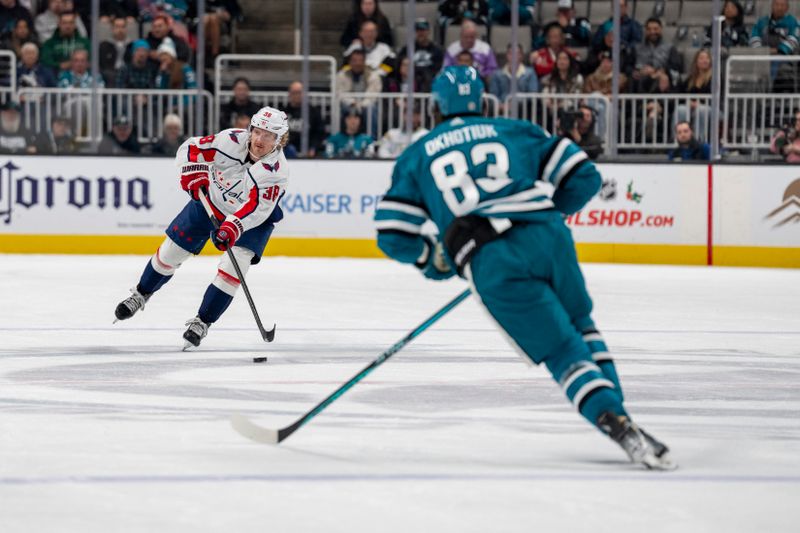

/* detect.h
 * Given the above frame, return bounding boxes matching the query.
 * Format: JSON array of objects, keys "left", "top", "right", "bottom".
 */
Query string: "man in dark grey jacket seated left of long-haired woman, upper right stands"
[{"left": 633, "top": 18, "right": 683, "bottom": 93}]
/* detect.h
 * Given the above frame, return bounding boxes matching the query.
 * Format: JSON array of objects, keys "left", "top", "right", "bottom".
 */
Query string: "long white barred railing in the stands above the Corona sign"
[{"left": 17, "top": 88, "right": 213, "bottom": 143}]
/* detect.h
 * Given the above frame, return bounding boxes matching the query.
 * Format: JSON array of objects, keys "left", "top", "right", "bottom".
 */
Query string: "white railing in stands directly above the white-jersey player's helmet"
[{"left": 214, "top": 54, "right": 338, "bottom": 129}]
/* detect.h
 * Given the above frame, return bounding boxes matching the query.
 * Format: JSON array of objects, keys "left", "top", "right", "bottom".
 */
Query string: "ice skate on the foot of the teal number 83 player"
[{"left": 597, "top": 413, "right": 678, "bottom": 470}]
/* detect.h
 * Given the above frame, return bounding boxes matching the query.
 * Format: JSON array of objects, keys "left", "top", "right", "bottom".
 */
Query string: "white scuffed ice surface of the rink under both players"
[{"left": 0, "top": 255, "right": 800, "bottom": 533}]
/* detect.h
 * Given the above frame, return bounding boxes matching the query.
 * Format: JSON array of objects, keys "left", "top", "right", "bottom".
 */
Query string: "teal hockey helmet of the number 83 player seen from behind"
[{"left": 431, "top": 66, "right": 483, "bottom": 117}]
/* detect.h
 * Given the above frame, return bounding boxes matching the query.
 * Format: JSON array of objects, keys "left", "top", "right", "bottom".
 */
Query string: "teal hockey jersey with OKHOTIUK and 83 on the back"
[{"left": 375, "top": 116, "right": 601, "bottom": 263}]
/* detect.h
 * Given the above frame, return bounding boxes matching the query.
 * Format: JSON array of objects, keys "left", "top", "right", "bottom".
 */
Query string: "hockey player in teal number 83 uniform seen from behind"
[{"left": 375, "top": 67, "right": 675, "bottom": 470}]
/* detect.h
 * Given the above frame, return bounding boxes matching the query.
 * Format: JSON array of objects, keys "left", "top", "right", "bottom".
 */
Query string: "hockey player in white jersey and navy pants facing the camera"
[{"left": 114, "top": 107, "right": 289, "bottom": 346}]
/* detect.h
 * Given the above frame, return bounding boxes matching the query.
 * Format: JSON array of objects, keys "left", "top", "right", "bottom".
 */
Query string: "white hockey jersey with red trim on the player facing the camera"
[{"left": 175, "top": 129, "right": 289, "bottom": 235}]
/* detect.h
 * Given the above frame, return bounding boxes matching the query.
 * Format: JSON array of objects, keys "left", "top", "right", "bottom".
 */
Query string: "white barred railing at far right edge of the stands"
[{"left": 722, "top": 55, "right": 800, "bottom": 150}]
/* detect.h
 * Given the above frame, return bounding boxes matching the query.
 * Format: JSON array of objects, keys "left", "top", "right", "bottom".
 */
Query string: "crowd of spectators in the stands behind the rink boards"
[{"left": 0, "top": 0, "right": 800, "bottom": 160}]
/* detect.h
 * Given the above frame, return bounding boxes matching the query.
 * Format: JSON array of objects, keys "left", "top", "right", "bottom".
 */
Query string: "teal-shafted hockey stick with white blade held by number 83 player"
[{"left": 231, "top": 289, "right": 470, "bottom": 444}]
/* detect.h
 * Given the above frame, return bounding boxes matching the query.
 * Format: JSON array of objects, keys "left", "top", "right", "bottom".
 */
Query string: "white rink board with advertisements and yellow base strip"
[{"left": 0, "top": 157, "right": 800, "bottom": 267}]
